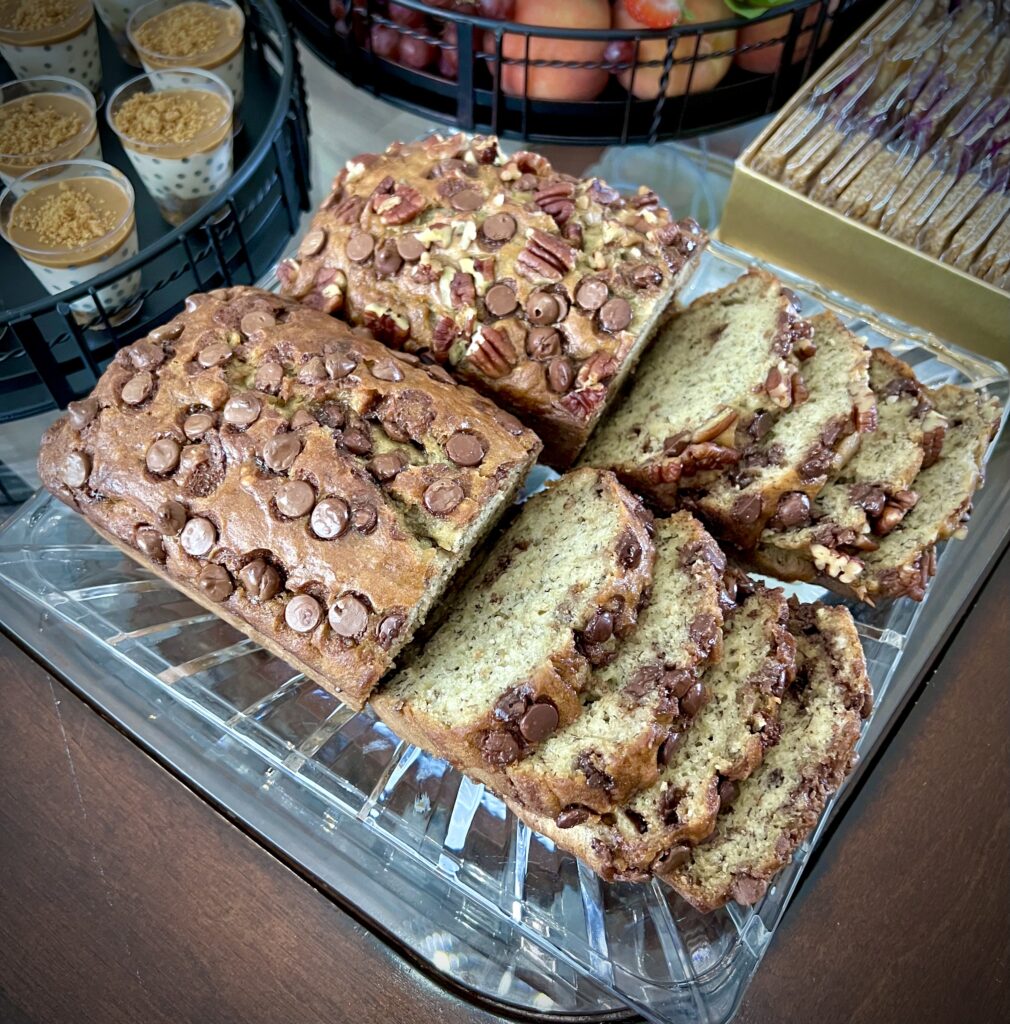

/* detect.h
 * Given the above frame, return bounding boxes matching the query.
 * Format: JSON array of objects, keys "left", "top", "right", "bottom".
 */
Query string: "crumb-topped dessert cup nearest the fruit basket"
[{"left": 127, "top": 0, "right": 246, "bottom": 108}]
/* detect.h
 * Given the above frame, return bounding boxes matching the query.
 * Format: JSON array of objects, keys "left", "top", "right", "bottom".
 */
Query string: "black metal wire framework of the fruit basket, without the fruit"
[{"left": 281, "top": 0, "right": 881, "bottom": 145}]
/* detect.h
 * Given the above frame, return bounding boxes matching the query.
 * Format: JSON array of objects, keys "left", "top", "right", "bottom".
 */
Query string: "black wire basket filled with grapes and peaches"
[{"left": 282, "top": 0, "right": 881, "bottom": 145}]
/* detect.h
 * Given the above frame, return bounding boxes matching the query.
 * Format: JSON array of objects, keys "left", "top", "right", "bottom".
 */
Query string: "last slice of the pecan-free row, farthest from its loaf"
[{"left": 658, "top": 604, "right": 872, "bottom": 912}]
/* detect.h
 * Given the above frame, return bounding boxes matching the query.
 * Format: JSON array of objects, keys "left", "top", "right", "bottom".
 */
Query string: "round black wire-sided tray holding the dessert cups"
[{"left": 0, "top": 0, "right": 309, "bottom": 422}]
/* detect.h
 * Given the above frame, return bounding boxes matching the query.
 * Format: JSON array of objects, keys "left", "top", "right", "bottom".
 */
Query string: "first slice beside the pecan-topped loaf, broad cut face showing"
[{"left": 581, "top": 270, "right": 811, "bottom": 509}]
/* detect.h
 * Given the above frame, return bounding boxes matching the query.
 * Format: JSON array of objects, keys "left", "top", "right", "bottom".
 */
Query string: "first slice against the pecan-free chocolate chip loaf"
[{"left": 372, "top": 469, "right": 656, "bottom": 774}]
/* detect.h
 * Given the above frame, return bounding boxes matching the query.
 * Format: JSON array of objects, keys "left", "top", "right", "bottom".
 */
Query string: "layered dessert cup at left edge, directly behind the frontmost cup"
[{"left": 0, "top": 76, "right": 101, "bottom": 185}]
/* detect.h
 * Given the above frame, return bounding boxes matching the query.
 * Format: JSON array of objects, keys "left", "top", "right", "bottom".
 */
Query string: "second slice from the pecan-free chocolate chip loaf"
[{"left": 508, "top": 512, "right": 726, "bottom": 817}]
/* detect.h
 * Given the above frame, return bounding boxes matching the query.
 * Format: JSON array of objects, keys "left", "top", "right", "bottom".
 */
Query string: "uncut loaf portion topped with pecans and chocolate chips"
[{"left": 278, "top": 135, "right": 707, "bottom": 468}]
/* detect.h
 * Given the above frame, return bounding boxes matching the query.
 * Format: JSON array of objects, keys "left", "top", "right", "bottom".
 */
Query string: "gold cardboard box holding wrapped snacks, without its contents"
[{"left": 719, "top": 0, "right": 1010, "bottom": 362}]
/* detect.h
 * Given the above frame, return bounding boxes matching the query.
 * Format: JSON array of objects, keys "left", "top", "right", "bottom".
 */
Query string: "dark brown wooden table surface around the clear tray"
[{"left": 0, "top": 553, "right": 1010, "bottom": 1024}]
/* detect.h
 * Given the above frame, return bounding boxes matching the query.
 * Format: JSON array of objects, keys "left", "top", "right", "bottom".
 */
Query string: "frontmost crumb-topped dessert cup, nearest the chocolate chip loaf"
[{"left": 0, "top": 160, "right": 140, "bottom": 329}]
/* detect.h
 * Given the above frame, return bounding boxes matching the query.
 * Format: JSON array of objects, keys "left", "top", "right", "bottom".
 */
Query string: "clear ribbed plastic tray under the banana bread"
[{"left": 0, "top": 244, "right": 1010, "bottom": 1022}]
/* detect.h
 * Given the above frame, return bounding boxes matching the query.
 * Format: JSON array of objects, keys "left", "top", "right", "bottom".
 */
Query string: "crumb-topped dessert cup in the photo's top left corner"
[{"left": 0, "top": 0, "right": 101, "bottom": 94}]
